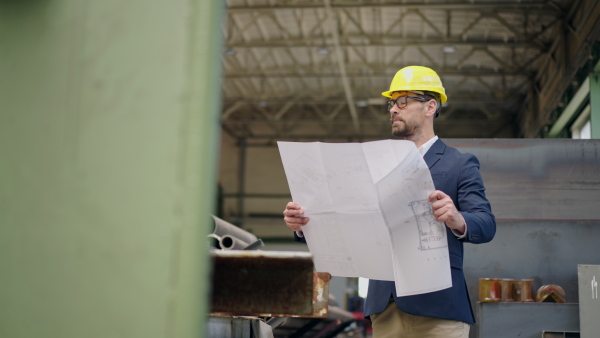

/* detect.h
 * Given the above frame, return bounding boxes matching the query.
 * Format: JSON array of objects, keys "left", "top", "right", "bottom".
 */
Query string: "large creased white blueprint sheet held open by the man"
[{"left": 277, "top": 140, "right": 452, "bottom": 296}]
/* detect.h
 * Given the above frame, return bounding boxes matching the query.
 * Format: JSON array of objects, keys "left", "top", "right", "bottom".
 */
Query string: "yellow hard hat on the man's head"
[{"left": 381, "top": 66, "right": 448, "bottom": 103}]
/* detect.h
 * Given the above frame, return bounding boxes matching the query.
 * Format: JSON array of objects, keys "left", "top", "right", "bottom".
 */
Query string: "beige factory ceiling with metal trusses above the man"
[{"left": 221, "top": 0, "right": 600, "bottom": 145}]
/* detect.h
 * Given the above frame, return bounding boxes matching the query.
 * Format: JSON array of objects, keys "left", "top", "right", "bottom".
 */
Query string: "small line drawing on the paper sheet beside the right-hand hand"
[{"left": 410, "top": 200, "right": 448, "bottom": 250}]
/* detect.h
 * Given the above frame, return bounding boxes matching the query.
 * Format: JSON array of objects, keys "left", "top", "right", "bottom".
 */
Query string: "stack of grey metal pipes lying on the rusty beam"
[{"left": 208, "top": 215, "right": 264, "bottom": 250}]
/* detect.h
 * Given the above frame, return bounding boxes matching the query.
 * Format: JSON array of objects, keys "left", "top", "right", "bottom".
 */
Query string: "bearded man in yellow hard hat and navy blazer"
[{"left": 283, "top": 66, "right": 496, "bottom": 338}]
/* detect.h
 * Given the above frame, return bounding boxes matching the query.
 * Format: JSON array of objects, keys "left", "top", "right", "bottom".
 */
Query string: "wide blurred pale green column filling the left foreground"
[{"left": 0, "top": 0, "right": 224, "bottom": 338}]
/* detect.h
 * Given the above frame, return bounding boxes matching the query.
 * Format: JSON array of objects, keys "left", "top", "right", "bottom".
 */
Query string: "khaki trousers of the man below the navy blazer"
[{"left": 371, "top": 301, "right": 470, "bottom": 338}]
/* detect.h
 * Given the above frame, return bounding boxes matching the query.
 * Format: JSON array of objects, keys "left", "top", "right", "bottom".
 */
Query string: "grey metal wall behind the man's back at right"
[{"left": 447, "top": 139, "right": 600, "bottom": 337}]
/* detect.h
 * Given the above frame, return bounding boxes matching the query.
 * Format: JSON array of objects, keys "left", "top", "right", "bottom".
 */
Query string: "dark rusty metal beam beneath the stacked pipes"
[{"left": 211, "top": 250, "right": 331, "bottom": 318}]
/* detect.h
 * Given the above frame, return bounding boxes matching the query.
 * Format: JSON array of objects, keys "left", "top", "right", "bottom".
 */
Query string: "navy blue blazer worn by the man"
[{"left": 294, "top": 139, "right": 496, "bottom": 324}]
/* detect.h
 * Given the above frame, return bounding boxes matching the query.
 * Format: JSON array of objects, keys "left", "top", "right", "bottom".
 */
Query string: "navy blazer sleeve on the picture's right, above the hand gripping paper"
[{"left": 457, "top": 154, "right": 496, "bottom": 243}]
